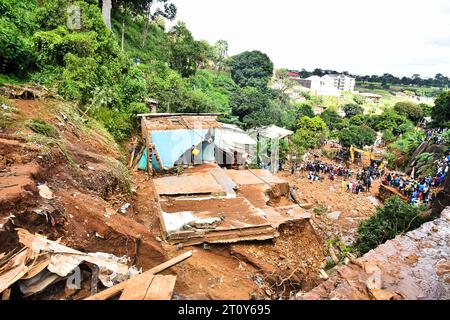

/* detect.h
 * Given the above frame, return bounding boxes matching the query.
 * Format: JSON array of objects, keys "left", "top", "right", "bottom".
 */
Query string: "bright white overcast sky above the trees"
[{"left": 172, "top": 0, "right": 450, "bottom": 77}]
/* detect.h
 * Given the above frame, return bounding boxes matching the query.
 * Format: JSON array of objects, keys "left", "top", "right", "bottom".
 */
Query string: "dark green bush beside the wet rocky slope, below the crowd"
[{"left": 355, "top": 196, "right": 427, "bottom": 253}]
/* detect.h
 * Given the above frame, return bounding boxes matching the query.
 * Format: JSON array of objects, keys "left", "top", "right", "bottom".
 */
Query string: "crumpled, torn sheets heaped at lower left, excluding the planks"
[{"left": 0, "top": 229, "right": 139, "bottom": 297}]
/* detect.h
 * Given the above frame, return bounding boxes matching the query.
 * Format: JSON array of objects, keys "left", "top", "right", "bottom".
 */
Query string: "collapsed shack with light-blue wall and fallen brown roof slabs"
[{"left": 134, "top": 114, "right": 309, "bottom": 244}]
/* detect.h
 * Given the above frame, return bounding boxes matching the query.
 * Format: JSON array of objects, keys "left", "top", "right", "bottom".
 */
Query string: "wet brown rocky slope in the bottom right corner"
[{"left": 300, "top": 207, "right": 450, "bottom": 300}]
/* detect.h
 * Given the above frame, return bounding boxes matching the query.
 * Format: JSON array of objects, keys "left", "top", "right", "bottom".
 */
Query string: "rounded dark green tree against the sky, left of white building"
[{"left": 230, "top": 51, "right": 273, "bottom": 89}]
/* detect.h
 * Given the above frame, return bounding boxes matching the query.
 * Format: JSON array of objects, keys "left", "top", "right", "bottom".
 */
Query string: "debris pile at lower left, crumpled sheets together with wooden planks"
[{"left": 0, "top": 229, "right": 192, "bottom": 300}]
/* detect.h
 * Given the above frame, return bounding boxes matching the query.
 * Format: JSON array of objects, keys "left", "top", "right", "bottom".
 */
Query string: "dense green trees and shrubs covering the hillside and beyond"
[{"left": 0, "top": 0, "right": 450, "bottom": 154}]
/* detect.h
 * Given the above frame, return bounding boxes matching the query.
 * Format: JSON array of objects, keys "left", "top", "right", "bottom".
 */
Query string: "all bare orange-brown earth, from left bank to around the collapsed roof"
[{"left": 0, "top": 100, "right": 384, "bottom": 299}]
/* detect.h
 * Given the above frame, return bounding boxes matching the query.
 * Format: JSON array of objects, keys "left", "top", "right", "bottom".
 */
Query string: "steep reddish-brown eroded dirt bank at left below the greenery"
[{"left": 0, "top": 100, "right": 166, "bottom": 269}]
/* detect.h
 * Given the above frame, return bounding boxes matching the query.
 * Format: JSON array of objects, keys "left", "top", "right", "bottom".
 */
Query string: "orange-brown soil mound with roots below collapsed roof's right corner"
[{"left": 230, "top": 220, "right": 324, "bottom": 299}]
